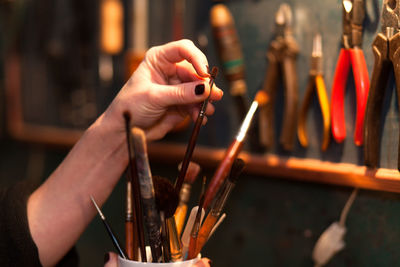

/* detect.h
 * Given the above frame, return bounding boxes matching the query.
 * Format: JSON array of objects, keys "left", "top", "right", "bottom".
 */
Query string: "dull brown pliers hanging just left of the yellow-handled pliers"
[{"left": 259, "top": 4, "right": 299, "bottom": 150}]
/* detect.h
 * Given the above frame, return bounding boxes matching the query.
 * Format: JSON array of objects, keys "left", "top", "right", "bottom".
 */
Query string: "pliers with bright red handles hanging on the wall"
[{"left": 331, "top": 0, "right": 369, "bottom": 146}]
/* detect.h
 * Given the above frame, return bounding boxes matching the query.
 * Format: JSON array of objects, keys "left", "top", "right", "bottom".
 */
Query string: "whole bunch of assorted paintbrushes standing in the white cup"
[{"left": 92, "top": 68, "right": 268, "bottom": 262}]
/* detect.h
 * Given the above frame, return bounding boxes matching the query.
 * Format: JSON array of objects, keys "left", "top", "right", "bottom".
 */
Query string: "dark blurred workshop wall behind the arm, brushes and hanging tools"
[{"left": 0, "top": 0, "right": 400, "bottom": 267}]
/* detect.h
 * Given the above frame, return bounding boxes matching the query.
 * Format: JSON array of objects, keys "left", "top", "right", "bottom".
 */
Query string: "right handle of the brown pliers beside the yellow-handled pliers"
[{"left": 279, "top": 51, "right": 299, "bottom": 151}]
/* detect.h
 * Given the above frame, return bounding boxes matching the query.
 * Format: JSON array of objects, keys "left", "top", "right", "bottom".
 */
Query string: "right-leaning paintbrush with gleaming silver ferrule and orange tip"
[{"left": 203, "top": 90, "right": 269, "bottom": 210}]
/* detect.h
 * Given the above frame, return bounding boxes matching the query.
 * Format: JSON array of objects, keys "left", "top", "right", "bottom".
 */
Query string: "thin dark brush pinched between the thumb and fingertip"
[{"left": 175, "top": 67, "right": 218, "bottom": 197}]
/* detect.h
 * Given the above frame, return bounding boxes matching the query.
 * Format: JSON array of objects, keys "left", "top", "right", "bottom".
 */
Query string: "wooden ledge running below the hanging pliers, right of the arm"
[{"left": 149, "top": 142, "right": 400, "bottom": 193}]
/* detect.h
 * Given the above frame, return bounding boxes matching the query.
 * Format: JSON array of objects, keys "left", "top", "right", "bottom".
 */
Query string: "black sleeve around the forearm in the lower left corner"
[{"left": 0, "top": 182, "right": 78, "bottom": 267}]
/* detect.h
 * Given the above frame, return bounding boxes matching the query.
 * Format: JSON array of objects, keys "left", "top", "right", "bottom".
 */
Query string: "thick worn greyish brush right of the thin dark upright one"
[{"left": 132, "top": 127, "right": 162, "bottom": 262}]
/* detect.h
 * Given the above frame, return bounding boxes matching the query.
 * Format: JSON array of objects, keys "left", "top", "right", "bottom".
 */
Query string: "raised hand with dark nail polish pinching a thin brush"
[{"left": 104, "top": 40, "right": 223, "bottom": 140}]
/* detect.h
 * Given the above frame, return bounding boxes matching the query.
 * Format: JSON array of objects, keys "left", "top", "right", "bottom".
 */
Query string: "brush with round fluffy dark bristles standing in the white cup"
[{"left": 153, "top": 175, "right": 182, "bottom": 262}]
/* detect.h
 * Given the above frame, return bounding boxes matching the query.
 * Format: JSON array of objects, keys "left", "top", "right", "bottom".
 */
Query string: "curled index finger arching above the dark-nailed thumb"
[{"left": 157, "top": 39, "right": 210, "bottom": 77}]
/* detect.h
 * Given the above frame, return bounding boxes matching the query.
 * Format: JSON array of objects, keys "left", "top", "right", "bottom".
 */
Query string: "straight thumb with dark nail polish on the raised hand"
[{"left": 155, "top": 81, "right": 210, "bottom": 106}]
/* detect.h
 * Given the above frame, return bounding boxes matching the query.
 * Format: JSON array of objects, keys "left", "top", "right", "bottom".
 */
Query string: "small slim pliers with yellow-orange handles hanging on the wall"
[{"left": 297, "top": 34, "right": 331, "bottom": 151}]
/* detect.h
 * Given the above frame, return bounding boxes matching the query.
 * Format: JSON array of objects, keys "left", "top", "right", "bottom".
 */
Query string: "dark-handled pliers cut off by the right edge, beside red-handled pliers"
[{"left": 364, "top": 0, "right": 400, "bottom": 169}]
